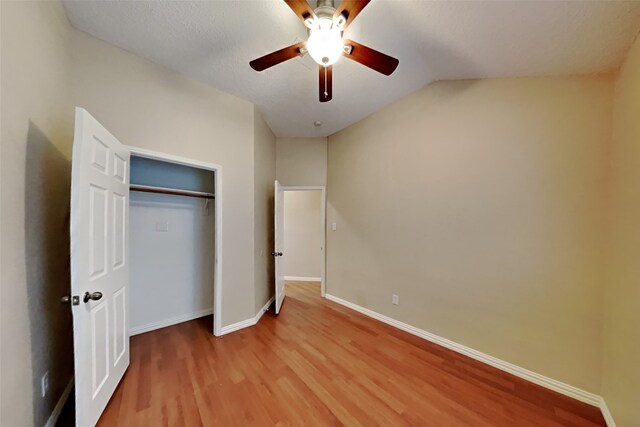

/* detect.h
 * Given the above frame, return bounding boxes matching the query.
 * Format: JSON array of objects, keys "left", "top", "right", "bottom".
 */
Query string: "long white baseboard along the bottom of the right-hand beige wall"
[{"left": 326, "top": 294, "right": 602, "bottom": 407}]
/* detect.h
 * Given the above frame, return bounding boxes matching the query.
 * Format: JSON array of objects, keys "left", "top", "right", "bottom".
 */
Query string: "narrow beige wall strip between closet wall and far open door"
[{"left": 253, "top": 109, "right": 276, "bottom": 312}]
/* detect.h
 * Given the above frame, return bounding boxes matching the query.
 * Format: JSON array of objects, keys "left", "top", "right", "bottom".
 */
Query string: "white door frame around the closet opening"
[{"left": 127, "top": 145, "right": 222, "bottom": 337}]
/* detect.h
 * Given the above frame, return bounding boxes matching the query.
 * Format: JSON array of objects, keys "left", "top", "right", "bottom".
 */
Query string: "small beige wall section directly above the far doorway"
[{"left": 276, "top": 138, "right": 327, "bottom": 186}]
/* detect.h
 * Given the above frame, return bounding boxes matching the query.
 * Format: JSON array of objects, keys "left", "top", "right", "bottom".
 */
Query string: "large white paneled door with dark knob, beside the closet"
[{"left": 70, "top": 108, "right": 129, "bottom": 427}]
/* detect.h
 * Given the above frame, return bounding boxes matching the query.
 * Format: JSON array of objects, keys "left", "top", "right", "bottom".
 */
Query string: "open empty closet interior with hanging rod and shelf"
[{"left": 129, "top": 155, "right": 215, "bottom": 335}]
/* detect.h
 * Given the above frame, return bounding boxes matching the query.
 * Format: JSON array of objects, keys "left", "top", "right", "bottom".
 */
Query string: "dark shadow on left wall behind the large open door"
[{"left": 25, "top": 122, "right": 73, "bottom": 425}]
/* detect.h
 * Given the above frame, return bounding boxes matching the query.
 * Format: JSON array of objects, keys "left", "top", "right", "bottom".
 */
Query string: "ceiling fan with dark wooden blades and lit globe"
[{"left": 249, "top": 0, "right": 399, "bottom": 102}]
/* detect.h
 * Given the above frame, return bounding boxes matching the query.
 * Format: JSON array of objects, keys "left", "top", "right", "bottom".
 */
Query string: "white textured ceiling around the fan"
[{"left": 64, "top": 0, "right": 640, "bottom": 136}]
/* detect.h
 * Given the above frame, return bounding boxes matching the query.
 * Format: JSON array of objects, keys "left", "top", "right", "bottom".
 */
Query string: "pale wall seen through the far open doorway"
[{"left": 282, "top": 190, "right": 323, "bottom": 278}]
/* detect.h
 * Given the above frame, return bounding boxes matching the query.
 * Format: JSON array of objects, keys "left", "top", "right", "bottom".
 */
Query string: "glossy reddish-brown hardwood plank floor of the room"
[{"left": 99, "top": 282, "right": 605, "bottom": 426}]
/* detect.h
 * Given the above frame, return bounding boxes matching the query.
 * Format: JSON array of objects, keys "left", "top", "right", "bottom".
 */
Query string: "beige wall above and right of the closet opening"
[{"left": 72, "top": 30, "right": 255, "bottom": 326}]
